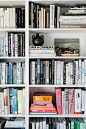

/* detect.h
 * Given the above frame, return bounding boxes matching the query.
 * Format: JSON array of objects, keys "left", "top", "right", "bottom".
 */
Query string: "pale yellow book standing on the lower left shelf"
[{"left": 18, "top": 90, "right": 23, "bottom": 114}]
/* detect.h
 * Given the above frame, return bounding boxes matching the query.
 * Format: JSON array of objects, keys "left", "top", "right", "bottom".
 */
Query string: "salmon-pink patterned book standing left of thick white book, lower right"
[{"left": 68, "top": 89, "right": 75, "bottom": 114}]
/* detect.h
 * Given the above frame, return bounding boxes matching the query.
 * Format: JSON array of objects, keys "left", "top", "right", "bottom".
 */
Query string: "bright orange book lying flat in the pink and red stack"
[{"left": 33, "top": 96, "right": 52, "bottom": 102}]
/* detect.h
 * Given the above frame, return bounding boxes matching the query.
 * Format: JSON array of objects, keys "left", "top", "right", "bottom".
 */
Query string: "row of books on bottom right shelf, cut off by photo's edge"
[{"left": 29, "top": 117, "right": 86, "bottom": 129}]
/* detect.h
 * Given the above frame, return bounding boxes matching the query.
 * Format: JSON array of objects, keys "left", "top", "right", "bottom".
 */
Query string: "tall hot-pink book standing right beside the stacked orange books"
[{"left": 55, "top": 89, "right": 62, "bottom": 114}]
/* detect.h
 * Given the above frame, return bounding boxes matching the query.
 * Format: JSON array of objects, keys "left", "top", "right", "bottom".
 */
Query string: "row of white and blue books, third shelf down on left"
[{"left": 0, "top": 61, "right": 25, "bottom": 84}]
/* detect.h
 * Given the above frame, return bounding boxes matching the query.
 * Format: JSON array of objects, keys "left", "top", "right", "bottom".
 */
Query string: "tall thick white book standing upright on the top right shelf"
[{"left": 50, "top": 5, "right": 55, "bottom": 28}]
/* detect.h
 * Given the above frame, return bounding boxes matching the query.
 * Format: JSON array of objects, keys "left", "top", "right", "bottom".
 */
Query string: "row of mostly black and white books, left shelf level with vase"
[{"left": 0, "top": 33, "right": 25, "bottom": 57}]
